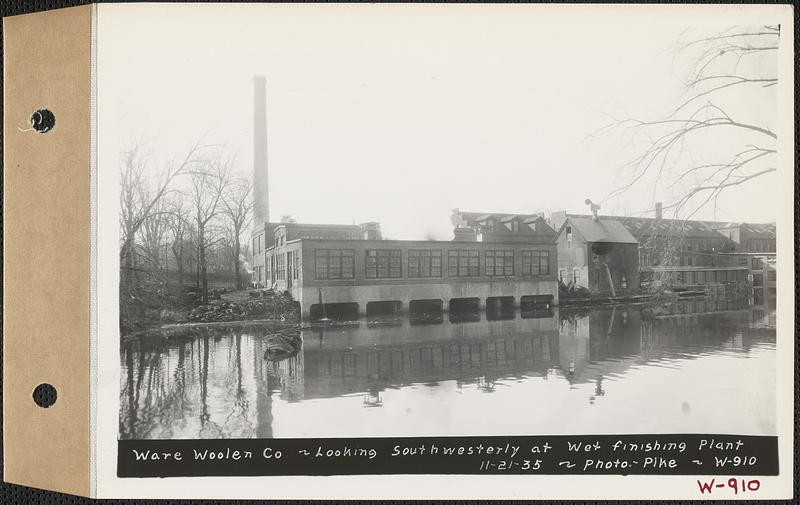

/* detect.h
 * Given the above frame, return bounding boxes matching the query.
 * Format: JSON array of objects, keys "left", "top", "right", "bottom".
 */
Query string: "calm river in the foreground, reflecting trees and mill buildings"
[{"left": 119, "top": 300, "right": 776, "bottom": 439}]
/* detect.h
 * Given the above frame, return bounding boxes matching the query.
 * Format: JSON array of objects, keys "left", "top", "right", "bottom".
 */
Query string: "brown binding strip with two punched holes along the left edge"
[{"left": 3, "top": 5, "right": 93, "bottom": 496}]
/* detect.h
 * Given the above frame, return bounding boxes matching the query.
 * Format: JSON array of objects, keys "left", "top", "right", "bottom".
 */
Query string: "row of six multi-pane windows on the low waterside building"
[{"left": 315, "top": 249, "right": 550, "bottom": 280}]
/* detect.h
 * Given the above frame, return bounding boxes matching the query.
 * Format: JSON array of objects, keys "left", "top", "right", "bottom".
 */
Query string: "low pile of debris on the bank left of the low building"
[{"left": 187, "top": 293, "right": 299, "bottom": 323}]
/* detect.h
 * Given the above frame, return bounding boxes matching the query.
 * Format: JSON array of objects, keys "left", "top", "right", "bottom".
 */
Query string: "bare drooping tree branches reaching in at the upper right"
[{"left": 595, "top": 26, "right": 780, "bottom": 219}]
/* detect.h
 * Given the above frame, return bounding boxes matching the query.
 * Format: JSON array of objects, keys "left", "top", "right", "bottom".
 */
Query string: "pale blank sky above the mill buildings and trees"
[{"left": 97, "top": 4, "right": 777, "bottom": 240}]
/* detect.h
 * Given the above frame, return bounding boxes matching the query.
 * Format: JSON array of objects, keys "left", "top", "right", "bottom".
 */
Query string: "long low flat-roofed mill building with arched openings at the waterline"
[{"left": 264, "top": 235, "right": 558, "bottom": 319}]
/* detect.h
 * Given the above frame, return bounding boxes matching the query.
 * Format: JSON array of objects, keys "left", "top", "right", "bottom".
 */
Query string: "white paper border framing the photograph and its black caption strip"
[{"left": 93, "top": 4, "right": 795, "bottom": 499}]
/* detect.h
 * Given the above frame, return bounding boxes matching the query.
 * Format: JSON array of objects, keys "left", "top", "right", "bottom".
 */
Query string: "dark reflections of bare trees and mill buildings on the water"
[{"left": 119, "top": 300, "right": 775, "bottom": 439}]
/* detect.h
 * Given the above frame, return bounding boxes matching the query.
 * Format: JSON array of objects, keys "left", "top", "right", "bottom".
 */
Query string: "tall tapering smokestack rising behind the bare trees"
[{"left": 253, "top": 75, "right": 269, "bottom": 226}]
